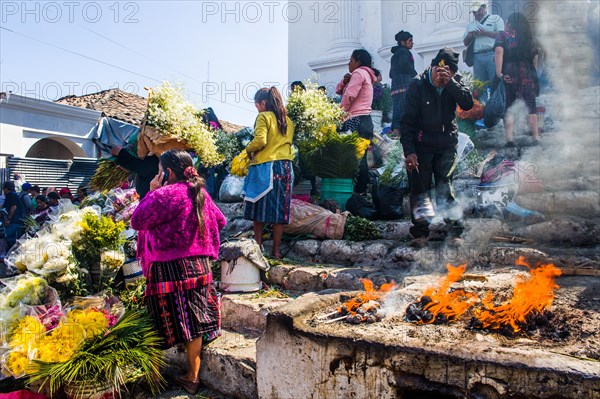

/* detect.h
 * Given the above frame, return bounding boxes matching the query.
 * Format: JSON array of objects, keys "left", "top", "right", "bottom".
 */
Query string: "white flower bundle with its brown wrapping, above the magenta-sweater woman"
[{"left": 138, "top": 82, "right": 223, "bottom": 167}]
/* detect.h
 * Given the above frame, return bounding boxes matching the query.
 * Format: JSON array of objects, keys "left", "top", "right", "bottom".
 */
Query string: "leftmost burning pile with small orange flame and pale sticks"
[{"left": 320, "top": 279, "right": 396, "bottom": 324}]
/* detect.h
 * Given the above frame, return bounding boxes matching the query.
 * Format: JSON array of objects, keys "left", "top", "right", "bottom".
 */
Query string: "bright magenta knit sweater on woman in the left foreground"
[{"left": 131, "top": 182, "right": 227, "bottom": 268}]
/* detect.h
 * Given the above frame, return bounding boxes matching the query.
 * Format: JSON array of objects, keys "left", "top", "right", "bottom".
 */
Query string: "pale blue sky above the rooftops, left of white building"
[{"left": 0, "top": 0, "right": 288, "bottom": 125}]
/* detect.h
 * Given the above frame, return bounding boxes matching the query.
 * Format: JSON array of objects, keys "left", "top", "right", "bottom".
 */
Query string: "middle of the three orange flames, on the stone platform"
[{"left": 421, "top": 263, "right": 479, "bottom": 324}]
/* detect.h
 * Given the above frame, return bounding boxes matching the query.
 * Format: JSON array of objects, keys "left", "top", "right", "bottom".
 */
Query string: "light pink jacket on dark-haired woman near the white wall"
[{"left": 336, "top": 66, "right": 375, "bottom": 117}]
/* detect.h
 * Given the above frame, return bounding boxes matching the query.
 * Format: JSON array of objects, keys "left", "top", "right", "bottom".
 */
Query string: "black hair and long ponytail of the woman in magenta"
[{"left": 159, "top": 150, "right": 206, "bottom": 235}]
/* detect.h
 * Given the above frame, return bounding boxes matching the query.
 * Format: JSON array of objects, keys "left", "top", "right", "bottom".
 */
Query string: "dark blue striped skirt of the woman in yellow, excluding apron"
[{"left": 244, "top": 161, "right": 294, "bottom": 224}]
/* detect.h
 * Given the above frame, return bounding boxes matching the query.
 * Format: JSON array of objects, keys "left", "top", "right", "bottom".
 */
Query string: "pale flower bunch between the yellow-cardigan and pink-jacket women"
[{"left": 287, "top": 82, "right": 346, "bottom": 141}]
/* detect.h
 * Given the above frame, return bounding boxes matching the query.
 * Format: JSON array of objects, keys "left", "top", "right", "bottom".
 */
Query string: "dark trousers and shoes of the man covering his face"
[{"left": 408, "top": 148, "right": 464, "bottom": 238}]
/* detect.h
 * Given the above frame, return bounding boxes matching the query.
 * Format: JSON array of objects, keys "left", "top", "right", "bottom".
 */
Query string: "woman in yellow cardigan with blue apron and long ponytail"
[{"left": 244, "top": 87, "right": 294, "bottom": 259}]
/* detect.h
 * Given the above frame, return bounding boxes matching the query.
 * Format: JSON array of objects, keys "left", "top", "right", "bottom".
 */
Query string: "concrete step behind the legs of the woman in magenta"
[{"left": 164, "top": 330, "right": 258, "bottom": 399}]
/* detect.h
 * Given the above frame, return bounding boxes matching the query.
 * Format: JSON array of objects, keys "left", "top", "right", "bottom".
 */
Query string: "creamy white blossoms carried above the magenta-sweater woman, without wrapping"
[{"left": 146, "top": 82, "right": 223, "bottom": 166}]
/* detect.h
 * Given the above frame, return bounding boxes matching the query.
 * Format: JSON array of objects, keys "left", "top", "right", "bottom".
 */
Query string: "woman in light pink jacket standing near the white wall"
[{"left": 336, "top": 49, "right": 376, "bottom": 193}]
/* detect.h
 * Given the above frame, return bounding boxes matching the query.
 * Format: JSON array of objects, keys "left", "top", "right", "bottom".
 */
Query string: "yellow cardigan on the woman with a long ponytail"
[{"left": 246, "top": 111, "right": 294, "bottom": 165}]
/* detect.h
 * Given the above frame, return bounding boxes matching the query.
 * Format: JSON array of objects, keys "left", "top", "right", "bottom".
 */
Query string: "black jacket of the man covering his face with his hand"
[{"left": 400, "top": 68, "right": 473, "bottom": 156}]
